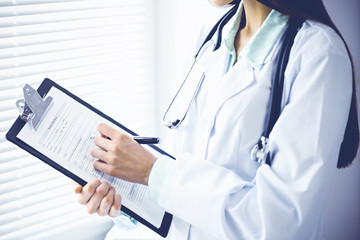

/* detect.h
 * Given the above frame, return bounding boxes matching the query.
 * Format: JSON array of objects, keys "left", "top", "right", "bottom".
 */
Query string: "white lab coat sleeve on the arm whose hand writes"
[{"left": 150, "top": 25, "right": 352, "bottom": 239}]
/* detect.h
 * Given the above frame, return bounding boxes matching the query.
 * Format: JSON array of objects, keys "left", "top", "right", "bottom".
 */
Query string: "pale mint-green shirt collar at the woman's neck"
[{"left": 223, "top": 2, "right": 289, "bottom": 69}]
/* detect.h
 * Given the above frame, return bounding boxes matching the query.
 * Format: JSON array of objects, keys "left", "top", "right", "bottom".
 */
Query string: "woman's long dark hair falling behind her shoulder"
[{"left": 231, "top": 0, "right": 360, "bottom": 168}]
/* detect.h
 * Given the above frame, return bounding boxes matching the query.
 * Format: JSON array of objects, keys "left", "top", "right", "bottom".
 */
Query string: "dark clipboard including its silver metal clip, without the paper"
[{"left": 6, "top": 78, "right": 174, "bottom": 237}]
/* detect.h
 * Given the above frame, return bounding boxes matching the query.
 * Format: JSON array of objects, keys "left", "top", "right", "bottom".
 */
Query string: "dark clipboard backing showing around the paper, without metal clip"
[{"left": 6, "top": 78, "right": 175, "bottom": 237}]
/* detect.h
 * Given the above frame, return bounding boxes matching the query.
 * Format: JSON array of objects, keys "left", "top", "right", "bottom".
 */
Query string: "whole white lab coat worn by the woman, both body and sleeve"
[{"left": 154, "top": 21, "right": 352, "bottom": 240}]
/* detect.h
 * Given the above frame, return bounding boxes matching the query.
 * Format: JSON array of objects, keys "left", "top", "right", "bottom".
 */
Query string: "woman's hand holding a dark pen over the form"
[{"left": 91, "top": 123, "right": 159, "bottom": 185}]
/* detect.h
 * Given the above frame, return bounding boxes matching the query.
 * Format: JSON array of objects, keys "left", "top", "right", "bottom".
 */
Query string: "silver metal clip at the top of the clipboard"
[{"left": 16, "top": 84, "right": 53, "bottom": 131}]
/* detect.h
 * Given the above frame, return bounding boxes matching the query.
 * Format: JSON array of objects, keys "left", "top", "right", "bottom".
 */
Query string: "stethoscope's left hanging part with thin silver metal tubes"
[{"left": 163, "top": 3, "right": 239, "bottom": 129}]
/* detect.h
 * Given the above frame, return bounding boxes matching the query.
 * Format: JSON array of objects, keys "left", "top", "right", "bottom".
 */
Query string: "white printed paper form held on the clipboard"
[{"left": 17, "top": 87, "right": 165, "bottom": 228}]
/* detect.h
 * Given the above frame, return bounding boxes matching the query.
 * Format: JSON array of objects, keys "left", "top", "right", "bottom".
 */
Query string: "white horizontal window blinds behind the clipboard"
[{"left": 0, "top": 0, "right": 154, "bottom": 239}]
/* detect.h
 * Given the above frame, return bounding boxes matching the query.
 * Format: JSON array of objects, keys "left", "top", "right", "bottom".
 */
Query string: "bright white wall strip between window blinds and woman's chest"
[{"left": 155, "top": 0, "right": 228, "bottom": 136}]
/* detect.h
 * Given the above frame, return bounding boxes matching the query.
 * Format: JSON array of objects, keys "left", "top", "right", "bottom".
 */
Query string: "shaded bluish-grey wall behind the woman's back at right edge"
[{"left": 325, "top": 0, "right": 360, "bottom": 240}]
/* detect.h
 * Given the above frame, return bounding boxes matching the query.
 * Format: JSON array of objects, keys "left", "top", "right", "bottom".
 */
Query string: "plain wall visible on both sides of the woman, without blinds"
[{"left": 155, "top": 0, "right": 360, "bottom": 240}]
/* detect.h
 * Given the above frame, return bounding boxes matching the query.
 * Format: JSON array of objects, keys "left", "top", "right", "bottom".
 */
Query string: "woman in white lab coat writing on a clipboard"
[{"left": 75, "top": 0, "right": 354, "bottom": 240}]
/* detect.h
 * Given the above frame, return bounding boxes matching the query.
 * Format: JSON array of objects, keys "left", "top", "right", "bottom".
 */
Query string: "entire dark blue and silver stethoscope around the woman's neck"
[{"left": 163, "top": 1, "right": 304, "bottom": 165}]
